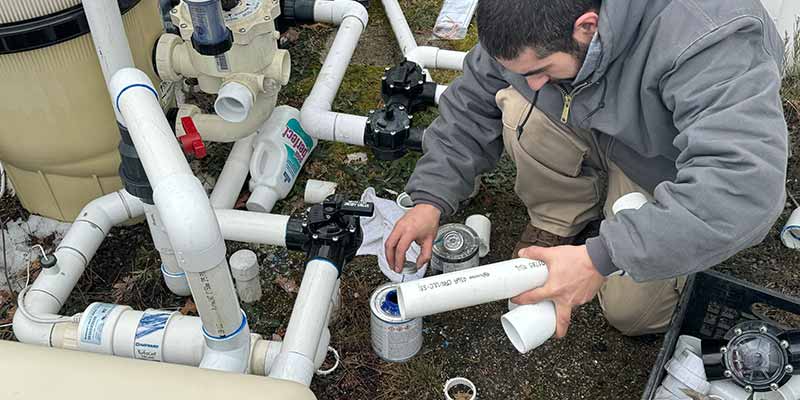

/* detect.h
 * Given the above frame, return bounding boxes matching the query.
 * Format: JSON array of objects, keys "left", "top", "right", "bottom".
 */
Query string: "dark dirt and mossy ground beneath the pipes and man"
[{"left": 0, "top": 0, "right": 800, "bottom": 400}]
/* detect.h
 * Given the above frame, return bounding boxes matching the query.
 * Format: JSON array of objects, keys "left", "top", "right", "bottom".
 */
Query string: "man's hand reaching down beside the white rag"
[{"left": 386, "top": 204, "right": 442, "bottom": 272}]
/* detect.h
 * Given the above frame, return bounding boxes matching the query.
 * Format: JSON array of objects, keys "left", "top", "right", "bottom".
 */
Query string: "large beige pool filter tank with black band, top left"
[{"left": 0, "top": 0, "right": 163, "bottom": 221}]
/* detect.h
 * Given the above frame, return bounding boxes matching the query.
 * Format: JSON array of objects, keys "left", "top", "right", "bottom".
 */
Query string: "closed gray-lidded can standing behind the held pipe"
[{"left": 431, "top": 224, "right": 480, "bottom": 273}]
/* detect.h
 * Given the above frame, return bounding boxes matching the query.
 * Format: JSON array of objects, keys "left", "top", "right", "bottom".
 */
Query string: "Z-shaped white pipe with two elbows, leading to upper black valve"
[{"left": 300, "top": 0, "right": 368, "bottom": 146}]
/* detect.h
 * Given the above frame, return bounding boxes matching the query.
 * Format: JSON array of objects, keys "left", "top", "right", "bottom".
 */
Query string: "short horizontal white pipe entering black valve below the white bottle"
[{"left": 216, "top": 210, "right": 289, "bottom": 247}]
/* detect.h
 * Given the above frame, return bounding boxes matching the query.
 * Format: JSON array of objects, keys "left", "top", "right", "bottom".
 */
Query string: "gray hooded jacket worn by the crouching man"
[{"left": 406, "top": 0, "right": 787, "bottom": 281}]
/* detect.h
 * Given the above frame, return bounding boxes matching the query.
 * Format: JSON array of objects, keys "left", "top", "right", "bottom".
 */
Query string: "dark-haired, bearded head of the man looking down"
[{"left": 477, "top": 0, "right": 601, "bottom": 90}]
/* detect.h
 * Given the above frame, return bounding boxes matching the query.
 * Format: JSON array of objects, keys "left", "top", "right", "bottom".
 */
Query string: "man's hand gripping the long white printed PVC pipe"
[{"left": 511, "top": 246, "right": 606, "bottom": 338}]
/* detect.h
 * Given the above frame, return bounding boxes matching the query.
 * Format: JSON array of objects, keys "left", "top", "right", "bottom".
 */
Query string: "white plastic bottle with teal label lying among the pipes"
[{"left": 247, "top": 106, "right": 317, "bottom": 212}]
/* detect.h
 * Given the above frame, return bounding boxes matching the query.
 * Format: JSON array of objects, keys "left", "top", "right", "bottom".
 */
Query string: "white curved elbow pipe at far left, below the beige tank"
[{"left": 13, "top": 190, "right": 144, "bottom": 346}]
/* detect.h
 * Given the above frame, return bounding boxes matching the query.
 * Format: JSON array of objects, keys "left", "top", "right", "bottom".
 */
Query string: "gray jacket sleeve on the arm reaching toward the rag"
[{"left": 406, "top": 45, "right": 509, "bottom": 215}]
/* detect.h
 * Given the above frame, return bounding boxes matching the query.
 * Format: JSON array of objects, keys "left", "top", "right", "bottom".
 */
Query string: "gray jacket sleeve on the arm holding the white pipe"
[{"left": 587, "top": 18, "right": 788, "bottom": 281}]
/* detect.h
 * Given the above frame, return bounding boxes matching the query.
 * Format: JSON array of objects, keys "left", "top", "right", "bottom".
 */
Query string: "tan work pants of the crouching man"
[{"left": 495, "top": 87, "right": 686, "bottom": 336}]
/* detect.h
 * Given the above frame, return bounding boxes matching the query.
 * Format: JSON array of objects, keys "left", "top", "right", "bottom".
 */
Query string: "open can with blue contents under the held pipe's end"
[{"left": 369, "top": 283, "right": 422, "bottom": 362}]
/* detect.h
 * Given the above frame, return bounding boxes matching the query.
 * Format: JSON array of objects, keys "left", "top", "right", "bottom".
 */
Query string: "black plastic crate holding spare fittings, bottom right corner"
[{"left": 642, "top": 271, "right": 800, "bottom": 400}]
